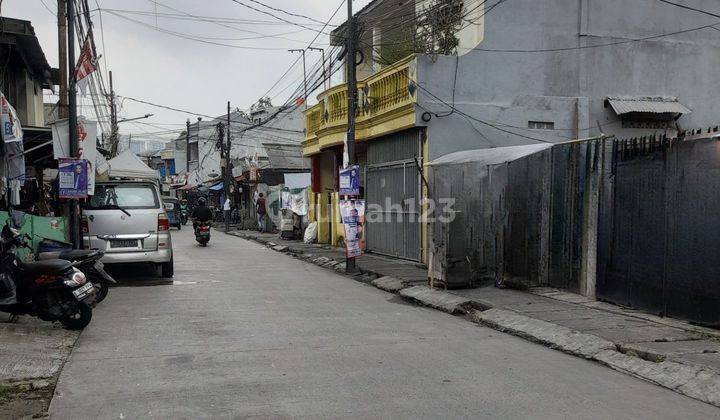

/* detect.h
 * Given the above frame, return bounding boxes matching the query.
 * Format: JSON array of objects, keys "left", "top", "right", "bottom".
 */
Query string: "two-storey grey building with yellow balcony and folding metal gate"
[{"left": 303, "top": 0, "right": 720, "bottom": 261}]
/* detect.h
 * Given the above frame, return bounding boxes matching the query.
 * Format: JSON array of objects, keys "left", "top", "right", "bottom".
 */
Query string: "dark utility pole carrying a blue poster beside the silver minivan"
[{"left": 67, "top": 0, "right": 83, "bottom": 249}]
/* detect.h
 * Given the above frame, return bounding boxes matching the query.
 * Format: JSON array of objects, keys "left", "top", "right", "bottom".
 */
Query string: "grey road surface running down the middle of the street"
[{"left": 50, "top": 229, "right": 720, "bottom": 419}]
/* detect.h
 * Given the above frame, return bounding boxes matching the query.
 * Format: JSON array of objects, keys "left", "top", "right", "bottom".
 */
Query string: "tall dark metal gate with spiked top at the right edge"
[{"left": 597, "top": 138, "right": 720, "bottom": 326}]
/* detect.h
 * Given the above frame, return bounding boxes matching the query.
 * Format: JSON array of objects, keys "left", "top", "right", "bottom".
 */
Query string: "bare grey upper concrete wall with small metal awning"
[{"left": 417, "top": 0, "right": 720, "bottom": 158}]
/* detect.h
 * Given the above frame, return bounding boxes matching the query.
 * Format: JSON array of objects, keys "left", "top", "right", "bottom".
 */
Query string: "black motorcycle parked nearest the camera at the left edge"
[{"left": 0, "top": 225, "right": 95, "bottom": 330}]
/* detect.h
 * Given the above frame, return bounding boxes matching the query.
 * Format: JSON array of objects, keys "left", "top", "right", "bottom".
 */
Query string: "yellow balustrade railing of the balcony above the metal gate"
[{"left": 305, "top": 56, "right": 415, "bottom": 146}]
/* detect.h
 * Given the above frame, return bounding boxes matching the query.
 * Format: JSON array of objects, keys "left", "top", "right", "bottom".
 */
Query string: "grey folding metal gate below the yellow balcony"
[{"left": 365, "top": 129, "right": 422, "bottom": 261}]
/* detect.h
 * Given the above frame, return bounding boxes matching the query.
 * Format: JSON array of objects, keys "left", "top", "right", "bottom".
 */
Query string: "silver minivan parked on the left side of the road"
[{"left": 82, "top": 181, "right": 174, "bottom": 277}]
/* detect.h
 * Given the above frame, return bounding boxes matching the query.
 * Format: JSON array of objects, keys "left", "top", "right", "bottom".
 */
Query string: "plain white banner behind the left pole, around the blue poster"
[{"left": 52, "top": 117, "right": 98, "bottom": 195}]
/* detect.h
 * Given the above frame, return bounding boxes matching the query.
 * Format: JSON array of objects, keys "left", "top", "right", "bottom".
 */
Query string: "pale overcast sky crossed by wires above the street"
[{"left": 1, "top": 0, "right": 370, "bottom": 139}]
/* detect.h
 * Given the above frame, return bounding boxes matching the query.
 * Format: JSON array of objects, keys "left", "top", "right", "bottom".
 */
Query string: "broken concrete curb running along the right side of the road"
[{"left": 228, "top": 234, "right": 720, "bottom": 407}]
